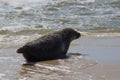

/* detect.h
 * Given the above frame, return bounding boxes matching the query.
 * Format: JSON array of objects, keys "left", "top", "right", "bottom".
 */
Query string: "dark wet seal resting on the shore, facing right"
[{"left": 17, "top": 28, "right": 81, "bottom": 63}]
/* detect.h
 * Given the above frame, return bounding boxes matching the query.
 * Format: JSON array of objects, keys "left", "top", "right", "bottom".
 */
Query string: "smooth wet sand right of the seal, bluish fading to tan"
[{"left": 70, "top": 37, "right": 120, "bottom": 80}]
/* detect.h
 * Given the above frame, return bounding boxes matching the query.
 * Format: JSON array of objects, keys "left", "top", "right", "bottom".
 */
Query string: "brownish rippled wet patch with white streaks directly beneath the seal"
[{"left": 19, "top": 55, "right": 96, "bottom": 80}]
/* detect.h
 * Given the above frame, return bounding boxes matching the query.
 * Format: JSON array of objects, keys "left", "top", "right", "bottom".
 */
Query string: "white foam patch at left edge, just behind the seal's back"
[{"left": 0, "top": 34, "right": 41, "bottom": 48}]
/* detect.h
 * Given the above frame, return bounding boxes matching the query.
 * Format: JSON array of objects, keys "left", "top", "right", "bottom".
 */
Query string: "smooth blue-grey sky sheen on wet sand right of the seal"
[{"left": 69, "top": 36, "right": 120, "bottom": 63}]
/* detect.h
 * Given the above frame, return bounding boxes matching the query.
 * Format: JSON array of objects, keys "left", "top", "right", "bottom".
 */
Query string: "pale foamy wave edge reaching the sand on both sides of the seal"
[{"left": 0, "top": 29, "right": 120, "bottom": 48}]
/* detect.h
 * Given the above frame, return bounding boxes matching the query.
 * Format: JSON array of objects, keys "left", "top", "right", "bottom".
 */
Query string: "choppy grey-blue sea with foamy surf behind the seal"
[{"left": 0, "top": 0, "right": 120, "bottom": 48}]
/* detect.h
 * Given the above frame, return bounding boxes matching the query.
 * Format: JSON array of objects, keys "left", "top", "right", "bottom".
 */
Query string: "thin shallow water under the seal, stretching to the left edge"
[{"left": 0, "top": 48, "right": 96, "bottom": 80}]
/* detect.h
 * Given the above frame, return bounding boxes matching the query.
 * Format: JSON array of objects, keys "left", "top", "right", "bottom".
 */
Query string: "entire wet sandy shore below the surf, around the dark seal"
[{"left": 0, "top": 37, "right": 120, "bottom": 80}]
